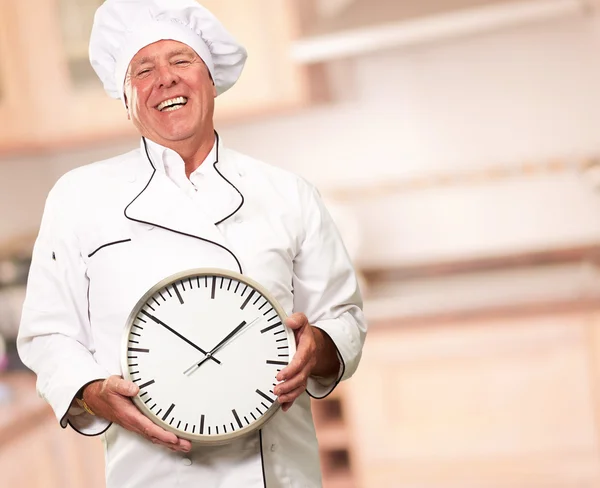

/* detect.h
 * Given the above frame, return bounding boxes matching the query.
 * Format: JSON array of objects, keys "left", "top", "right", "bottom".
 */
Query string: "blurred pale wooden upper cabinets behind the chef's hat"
[{"left": 0, "top": 0, "right": 311, "bottom": 153}]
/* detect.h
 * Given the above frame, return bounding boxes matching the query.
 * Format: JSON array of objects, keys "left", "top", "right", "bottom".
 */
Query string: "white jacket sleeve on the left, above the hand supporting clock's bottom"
[{"left": 17, "top": 180, "right": 110, "bottom": 435}]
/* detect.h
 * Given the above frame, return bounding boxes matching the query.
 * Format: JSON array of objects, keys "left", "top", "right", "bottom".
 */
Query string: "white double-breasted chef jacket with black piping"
[{"left": 17, "top": 135, "right": 367, "bottom": 488}]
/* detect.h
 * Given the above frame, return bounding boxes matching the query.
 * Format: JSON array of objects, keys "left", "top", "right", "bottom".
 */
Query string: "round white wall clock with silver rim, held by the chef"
[{"left": 122, "top": 269, "right": 296, "bottom": 444}]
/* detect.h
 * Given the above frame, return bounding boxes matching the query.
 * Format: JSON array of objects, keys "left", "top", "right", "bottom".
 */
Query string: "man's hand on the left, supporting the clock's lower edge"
[{"left": 83, "top": 376, "right": 192, "bottom": 452}]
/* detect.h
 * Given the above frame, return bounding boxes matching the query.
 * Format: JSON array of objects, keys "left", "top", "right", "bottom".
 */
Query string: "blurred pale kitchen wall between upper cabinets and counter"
[{"left": 0, "top": 13, "right": 600, "bottom": 267}]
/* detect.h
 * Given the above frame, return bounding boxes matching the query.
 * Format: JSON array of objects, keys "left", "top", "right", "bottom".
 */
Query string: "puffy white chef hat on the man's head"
[{"left": 89, "top": 0, "right": 247, "bottom": 99}]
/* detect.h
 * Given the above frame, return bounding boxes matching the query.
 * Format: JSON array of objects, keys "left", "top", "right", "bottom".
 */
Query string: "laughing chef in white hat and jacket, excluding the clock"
[{"left": 18, "top": 0, "right": 366, "bottom": 488}]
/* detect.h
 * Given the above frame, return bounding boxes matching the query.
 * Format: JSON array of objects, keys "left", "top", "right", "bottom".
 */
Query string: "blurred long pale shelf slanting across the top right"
[{"left": 292, "top": 0, "right": 593, "bottom": 64}]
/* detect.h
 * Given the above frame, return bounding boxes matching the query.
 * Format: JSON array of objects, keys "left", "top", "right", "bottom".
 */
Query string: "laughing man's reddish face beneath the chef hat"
[{"left": 125, "top": 40, "right": 217, "bottom": 147}]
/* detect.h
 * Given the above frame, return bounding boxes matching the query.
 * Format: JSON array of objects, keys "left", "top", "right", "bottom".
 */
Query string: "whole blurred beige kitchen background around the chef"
[{"left": 0, "top": 0, "right": 600, "bottom": 488}]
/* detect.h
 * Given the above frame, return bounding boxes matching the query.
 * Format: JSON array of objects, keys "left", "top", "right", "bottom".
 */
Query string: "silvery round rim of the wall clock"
[{"left": 121, "top": 268, "right": 296, "bottom": 446}]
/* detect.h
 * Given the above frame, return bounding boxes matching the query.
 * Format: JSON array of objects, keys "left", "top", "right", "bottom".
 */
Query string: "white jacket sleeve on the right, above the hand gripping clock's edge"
[{"left": 293, "top": 181, "right": 367, "bottom": 398}]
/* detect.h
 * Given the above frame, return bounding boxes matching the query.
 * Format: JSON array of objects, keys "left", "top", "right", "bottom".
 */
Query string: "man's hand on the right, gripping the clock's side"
[{"left": 273, "top": 313, "right": 339, "bottom": 412}]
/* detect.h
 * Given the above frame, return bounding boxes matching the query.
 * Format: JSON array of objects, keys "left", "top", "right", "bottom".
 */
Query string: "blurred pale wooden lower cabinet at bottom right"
[{"left": 344, "top": 313, "right": 600, "bottom": 488}]
